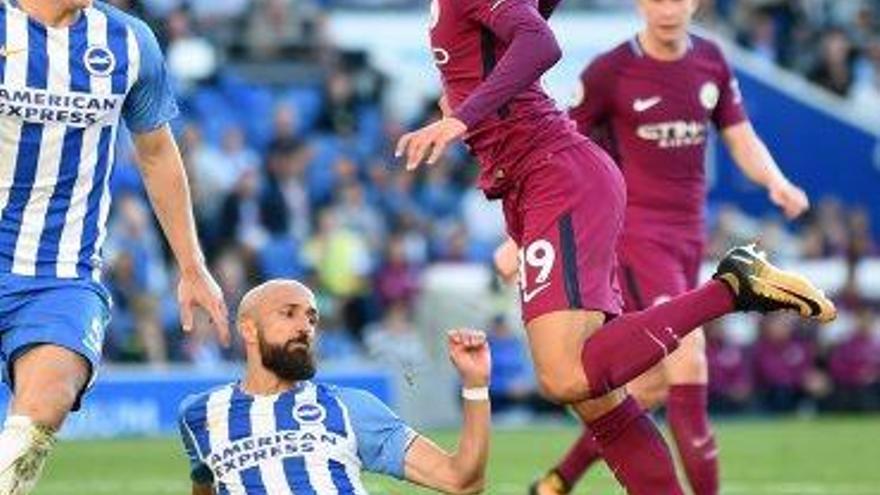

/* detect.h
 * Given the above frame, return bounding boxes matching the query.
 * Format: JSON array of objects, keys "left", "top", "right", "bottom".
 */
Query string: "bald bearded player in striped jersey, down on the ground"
[{"left": 180, "top": 280, "right": 491, "bottom": 495}]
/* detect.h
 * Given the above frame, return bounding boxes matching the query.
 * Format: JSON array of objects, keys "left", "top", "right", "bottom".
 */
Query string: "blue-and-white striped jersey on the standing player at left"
[{"left": 0, "top": 0, "right": 177, "bottom": 280}]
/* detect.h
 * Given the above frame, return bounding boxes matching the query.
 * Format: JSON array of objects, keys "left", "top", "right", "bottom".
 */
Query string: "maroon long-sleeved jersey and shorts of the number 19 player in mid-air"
[{"left": 431, "top": 0, "right": 625, "bottom": 322}]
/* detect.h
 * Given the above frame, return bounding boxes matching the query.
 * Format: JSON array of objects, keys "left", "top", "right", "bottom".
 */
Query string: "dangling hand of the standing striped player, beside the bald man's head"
[{"left": 177, "top": 265, "right": 229, "bottom": 346}]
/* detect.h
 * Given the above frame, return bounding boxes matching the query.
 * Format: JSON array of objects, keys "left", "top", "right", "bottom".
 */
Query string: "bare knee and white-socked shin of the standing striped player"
[{"left": 0, "top": 345, "right": 90, "bottom": 495}]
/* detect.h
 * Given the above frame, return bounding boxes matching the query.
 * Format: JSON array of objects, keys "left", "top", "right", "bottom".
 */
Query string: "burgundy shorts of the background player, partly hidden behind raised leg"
[{"left": 617, "top": 235, "right": 703, "bottom": 312}]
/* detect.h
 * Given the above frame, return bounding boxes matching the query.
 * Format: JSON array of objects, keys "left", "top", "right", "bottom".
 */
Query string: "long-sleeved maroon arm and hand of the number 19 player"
[{"left": 396, "top": 0, "right": 562, "bottom": 170}]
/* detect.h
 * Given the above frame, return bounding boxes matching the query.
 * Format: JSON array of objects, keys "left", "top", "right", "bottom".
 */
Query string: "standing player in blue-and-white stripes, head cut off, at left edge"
[{"left": 0, "top": 0, "right": 228, "bottom": 495}]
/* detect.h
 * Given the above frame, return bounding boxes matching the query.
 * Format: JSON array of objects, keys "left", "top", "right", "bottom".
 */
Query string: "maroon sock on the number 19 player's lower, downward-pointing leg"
[{"left": 589, "top": 397, "right": 684, "bottom": 495}]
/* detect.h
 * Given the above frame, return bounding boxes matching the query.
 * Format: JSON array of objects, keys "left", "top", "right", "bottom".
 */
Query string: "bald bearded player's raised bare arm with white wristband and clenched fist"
[{"left": 404, "top": 330, "right": 492, "bottom": 494}]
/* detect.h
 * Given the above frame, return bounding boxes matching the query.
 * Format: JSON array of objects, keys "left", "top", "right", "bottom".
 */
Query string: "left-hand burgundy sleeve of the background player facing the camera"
[{"left": 568, "top": 60, "right": 613, "bottom": 135}]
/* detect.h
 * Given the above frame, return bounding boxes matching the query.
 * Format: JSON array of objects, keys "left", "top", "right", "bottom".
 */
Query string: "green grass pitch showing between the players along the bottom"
[{"left": 35, "top": 417, "right": 880, "bottom": 495}]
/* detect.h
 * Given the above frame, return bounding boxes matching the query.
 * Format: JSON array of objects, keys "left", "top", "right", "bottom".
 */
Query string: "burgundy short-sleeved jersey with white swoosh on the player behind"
[{"left": 570, "top": 36, "right": 747, "bottom": 239}]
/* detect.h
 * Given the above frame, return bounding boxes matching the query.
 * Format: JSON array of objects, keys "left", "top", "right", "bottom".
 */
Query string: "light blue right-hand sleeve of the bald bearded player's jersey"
[{"left": 339, "top": 389, "right": 418, "bottom": 479}]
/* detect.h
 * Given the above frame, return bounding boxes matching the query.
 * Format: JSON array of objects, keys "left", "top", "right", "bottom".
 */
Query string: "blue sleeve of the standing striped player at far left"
[{"left": 122, "top": 21, "right": 178, "bottom": 134}]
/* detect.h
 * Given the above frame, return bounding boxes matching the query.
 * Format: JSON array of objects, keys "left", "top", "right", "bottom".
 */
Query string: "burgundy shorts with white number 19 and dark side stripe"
[{"left": 503, "top": 142, "right": 626, "bottom": 323}]
